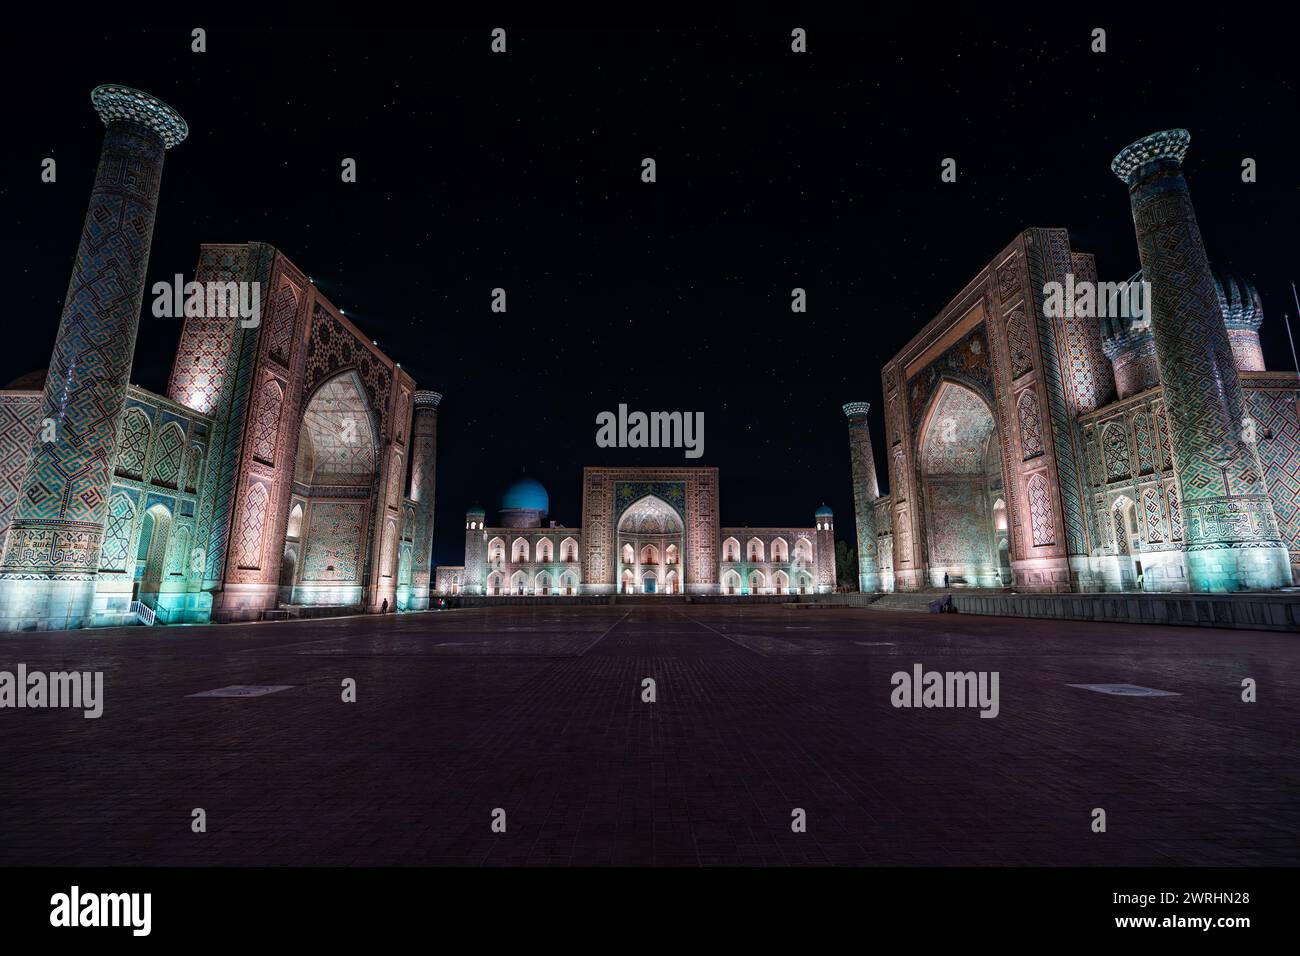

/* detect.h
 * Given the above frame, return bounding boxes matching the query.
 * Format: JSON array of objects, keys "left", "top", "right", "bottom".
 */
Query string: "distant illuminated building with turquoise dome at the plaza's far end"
[{"left": 434, "top": 468, "right": 836, "bottom": 597}]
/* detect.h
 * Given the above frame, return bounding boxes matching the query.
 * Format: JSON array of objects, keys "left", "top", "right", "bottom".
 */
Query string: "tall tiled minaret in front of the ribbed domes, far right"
[{"left": 1110, "top": 130, "right": 1291, "bottom": 592}]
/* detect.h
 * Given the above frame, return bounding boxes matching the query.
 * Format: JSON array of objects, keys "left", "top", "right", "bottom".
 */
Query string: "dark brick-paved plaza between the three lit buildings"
[{"left": 0, "top": 605, "right": 1300, "bottom": 866}]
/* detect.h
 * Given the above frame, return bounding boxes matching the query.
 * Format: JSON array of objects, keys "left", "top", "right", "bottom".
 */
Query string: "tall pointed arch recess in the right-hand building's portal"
[{"left": 918, "top": 381, "right": 1010, "bottom": 588}]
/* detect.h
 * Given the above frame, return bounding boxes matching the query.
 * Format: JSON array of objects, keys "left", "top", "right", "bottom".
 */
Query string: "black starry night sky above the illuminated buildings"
[{"left": 0, "top": 24, "right": 1300, "bottom": 563}]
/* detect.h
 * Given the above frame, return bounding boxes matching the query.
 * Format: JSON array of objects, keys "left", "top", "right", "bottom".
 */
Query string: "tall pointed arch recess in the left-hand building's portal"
[{"left": 281, "top": 372, "right": 378, "bottom": 606}]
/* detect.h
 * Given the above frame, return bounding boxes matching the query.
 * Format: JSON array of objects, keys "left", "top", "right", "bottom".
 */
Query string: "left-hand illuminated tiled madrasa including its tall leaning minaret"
[{"left": 0, "top": 87, "right": 441, "bottom": 630}]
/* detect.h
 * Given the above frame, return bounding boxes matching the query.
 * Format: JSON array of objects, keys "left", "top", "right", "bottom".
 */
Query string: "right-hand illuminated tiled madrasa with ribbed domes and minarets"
[{"left": 845, "top": 130, "right": 1300, "bottom": 592}]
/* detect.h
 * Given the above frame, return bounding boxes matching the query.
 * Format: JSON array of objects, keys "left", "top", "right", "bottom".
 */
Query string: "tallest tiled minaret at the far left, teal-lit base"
[{"left": 0, "top": 86, "right": 189, "bottom": 630}]
